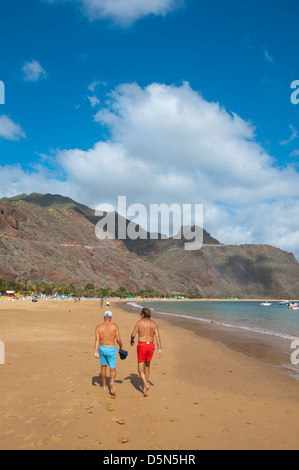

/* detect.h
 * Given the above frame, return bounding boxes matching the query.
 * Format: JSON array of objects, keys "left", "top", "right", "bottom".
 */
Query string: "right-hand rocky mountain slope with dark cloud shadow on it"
[{"left": 147, "top": 245, "right": 299, "bottom": 298}]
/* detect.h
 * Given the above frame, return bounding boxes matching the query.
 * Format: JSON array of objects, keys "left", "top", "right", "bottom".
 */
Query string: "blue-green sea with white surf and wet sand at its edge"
[{"left": 127, "top": 301, "right": 299, "bottom": 379}]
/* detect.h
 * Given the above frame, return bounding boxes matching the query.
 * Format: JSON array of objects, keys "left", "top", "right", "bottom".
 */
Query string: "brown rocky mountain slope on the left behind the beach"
[{"left": 0, "top": 194, "right": 187, "bottom": 291}]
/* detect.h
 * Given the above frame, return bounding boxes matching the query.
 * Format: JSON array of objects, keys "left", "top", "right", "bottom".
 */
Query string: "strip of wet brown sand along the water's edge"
[{"left": 120, "top": 300, "right": 299, "bottom": 381}]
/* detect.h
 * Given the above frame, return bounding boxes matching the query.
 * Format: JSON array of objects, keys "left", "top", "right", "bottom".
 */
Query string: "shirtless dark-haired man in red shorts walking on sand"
[{"left": 131, "top": 308, "right": 162, "bottom": 397}]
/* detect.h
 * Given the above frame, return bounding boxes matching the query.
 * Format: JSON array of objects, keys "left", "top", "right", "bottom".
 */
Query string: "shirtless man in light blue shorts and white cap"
[{"left": 94, "top": 310, "right": 122, "bottom": 395}]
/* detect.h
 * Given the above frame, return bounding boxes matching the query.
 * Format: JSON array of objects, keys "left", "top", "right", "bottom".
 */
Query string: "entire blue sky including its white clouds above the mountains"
[{"left": 0, "top": 0, "right": 299, "bottom": 257}]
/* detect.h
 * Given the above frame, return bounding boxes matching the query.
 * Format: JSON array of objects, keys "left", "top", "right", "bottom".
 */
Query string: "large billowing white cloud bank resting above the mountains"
[{"left": 0, "top": 83, "right": 299, "bottom": 259}]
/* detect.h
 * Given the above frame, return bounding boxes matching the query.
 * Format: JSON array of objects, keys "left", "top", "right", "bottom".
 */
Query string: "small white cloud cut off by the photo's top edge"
[{"left": 46, "top": 0, "right": 184, "bottom": 26}]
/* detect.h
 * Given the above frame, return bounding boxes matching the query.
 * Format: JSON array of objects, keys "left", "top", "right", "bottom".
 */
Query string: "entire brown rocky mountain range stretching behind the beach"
[{"left": 0, "top": 193, "right": 299, "bottom": 298}]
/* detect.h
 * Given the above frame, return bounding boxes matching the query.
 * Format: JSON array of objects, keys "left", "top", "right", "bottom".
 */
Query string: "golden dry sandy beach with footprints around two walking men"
[{"left": 0, "top": 300, "right": 299, "bottom": 451}]
